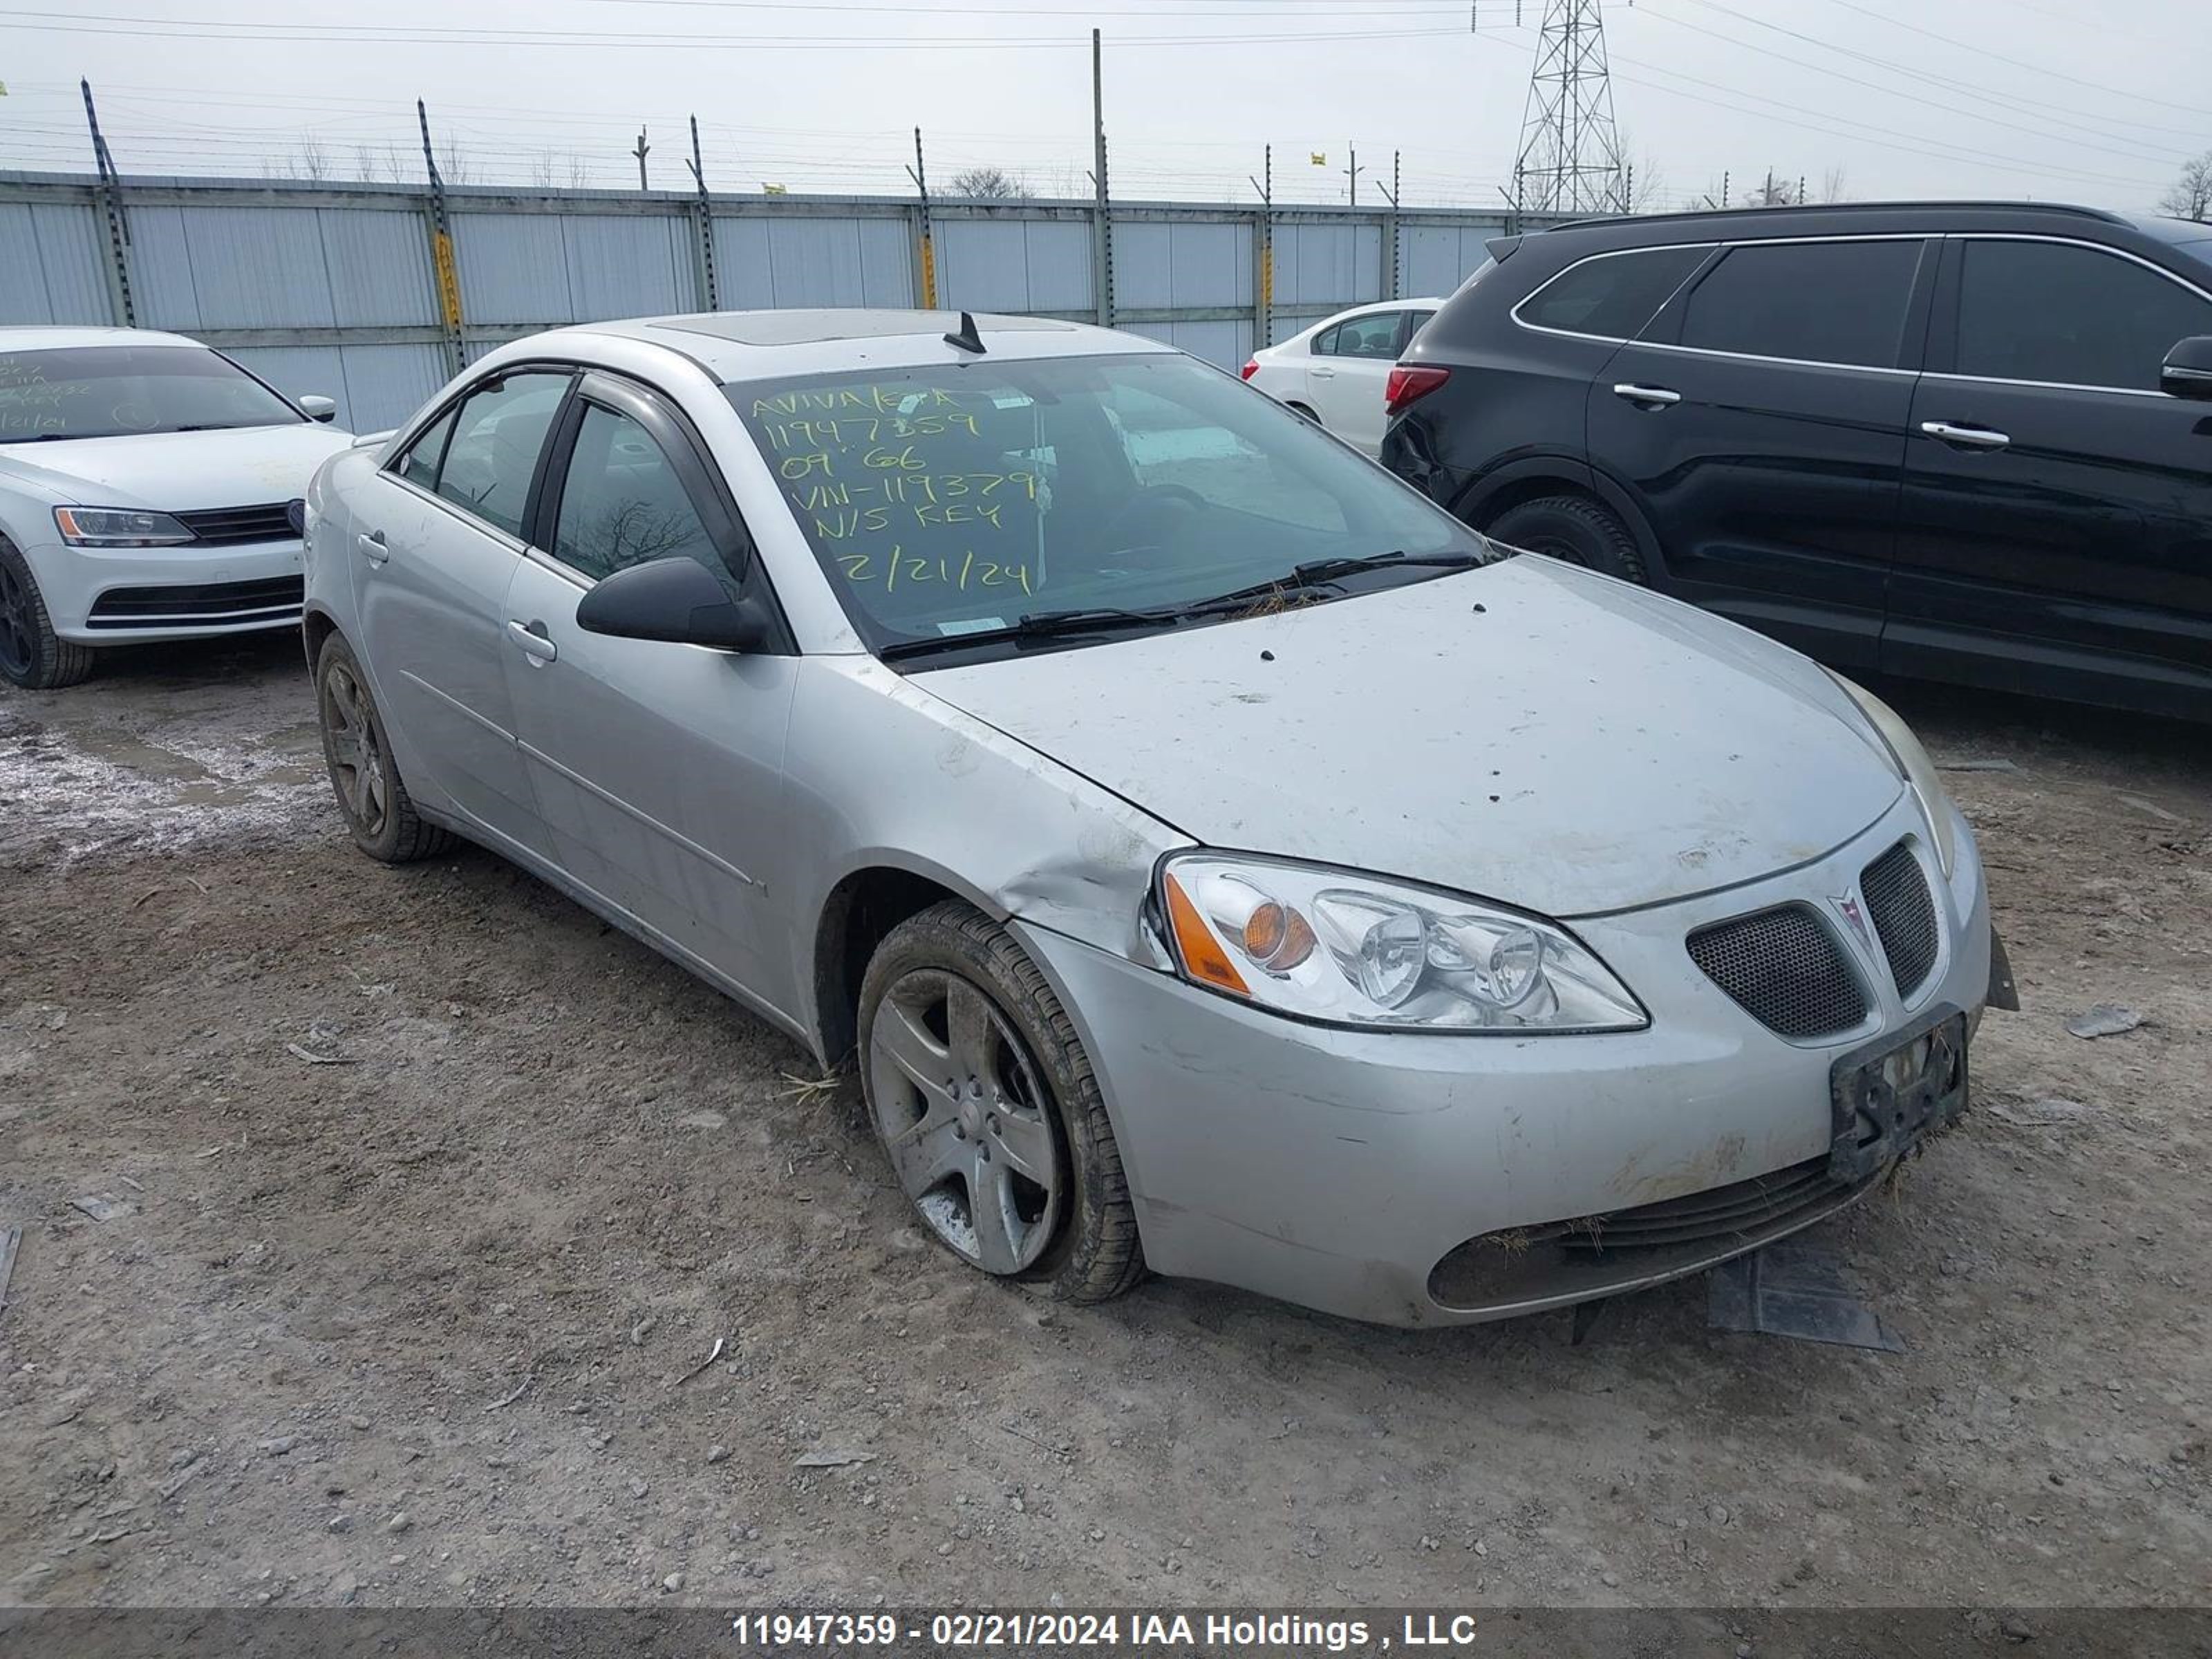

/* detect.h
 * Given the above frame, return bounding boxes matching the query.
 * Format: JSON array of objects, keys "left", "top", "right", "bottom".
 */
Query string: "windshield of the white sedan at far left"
[{"left": 0, "top": 345, "right": 306, "bottom": 442}]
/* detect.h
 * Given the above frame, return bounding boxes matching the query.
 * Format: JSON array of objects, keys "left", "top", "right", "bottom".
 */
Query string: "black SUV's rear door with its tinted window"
[{"left": 1588, "top": 236, "right": 1938, "bottom": 666}]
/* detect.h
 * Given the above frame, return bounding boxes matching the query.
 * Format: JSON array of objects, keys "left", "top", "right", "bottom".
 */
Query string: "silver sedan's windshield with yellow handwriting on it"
[{"left": 726, "top": 356, "right": 1484, "bottom": 655}]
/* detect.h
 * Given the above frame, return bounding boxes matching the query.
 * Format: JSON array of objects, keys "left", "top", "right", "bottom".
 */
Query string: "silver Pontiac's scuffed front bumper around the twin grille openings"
[{"left": 1018, "top": 794, "right": 1991, "bottom": 1325}]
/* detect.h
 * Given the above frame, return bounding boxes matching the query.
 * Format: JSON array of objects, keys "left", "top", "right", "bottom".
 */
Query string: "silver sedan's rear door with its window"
[{"left": 352, "top": 367, "right": 573, "bottom": 852}]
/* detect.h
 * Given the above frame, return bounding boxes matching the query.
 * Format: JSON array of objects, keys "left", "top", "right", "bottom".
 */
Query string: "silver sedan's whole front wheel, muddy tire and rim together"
[{"left": 861, "top": 900, "right": 1143, "bottom": 1303}]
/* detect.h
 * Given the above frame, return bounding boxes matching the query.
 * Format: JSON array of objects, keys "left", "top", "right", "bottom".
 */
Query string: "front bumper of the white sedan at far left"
[{"left": 24, "top": 538, "right": 303, "bottom": 646}]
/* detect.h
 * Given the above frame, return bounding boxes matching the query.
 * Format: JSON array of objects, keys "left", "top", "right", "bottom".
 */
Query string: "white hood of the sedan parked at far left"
[{"left": 0, "top": 420, "right": 354, "bottom": 513}]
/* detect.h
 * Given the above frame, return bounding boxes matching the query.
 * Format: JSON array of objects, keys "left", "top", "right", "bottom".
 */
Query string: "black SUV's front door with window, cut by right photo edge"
[{"left": 1882, "top": 236, "right": 2212, "bottom": 712}]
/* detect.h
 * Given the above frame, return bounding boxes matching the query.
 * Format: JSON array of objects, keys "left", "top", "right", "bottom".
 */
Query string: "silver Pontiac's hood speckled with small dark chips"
[{"left": 914, "top": 555, "right": 1904, "bottom": 918}]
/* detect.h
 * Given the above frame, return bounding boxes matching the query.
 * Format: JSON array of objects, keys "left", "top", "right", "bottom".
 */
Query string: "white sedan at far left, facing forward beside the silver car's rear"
[{"left": 0, "top": 328, "right": 352, "bottom": 690}]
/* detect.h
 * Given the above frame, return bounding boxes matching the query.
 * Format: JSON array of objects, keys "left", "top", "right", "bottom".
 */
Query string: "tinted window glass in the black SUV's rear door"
[{"left": 1681, "top": 239, "right": 1920, "bottom": 369}]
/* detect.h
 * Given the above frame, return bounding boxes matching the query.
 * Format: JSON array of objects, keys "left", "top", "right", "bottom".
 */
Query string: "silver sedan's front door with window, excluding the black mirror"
[{"left": 500, "top": 374, "right": 798, "bottom": 1018}]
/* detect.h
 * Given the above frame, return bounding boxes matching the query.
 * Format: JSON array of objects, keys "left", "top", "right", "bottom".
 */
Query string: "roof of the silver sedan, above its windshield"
[{"left": 515, "top": 308, "right": 1177, "bottom": 383}]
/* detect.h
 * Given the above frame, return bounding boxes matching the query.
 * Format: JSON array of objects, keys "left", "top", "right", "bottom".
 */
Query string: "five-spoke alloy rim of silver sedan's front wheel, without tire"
[{"left": 867, "top": 969, "right": 1066, "bottom": 1274}]
